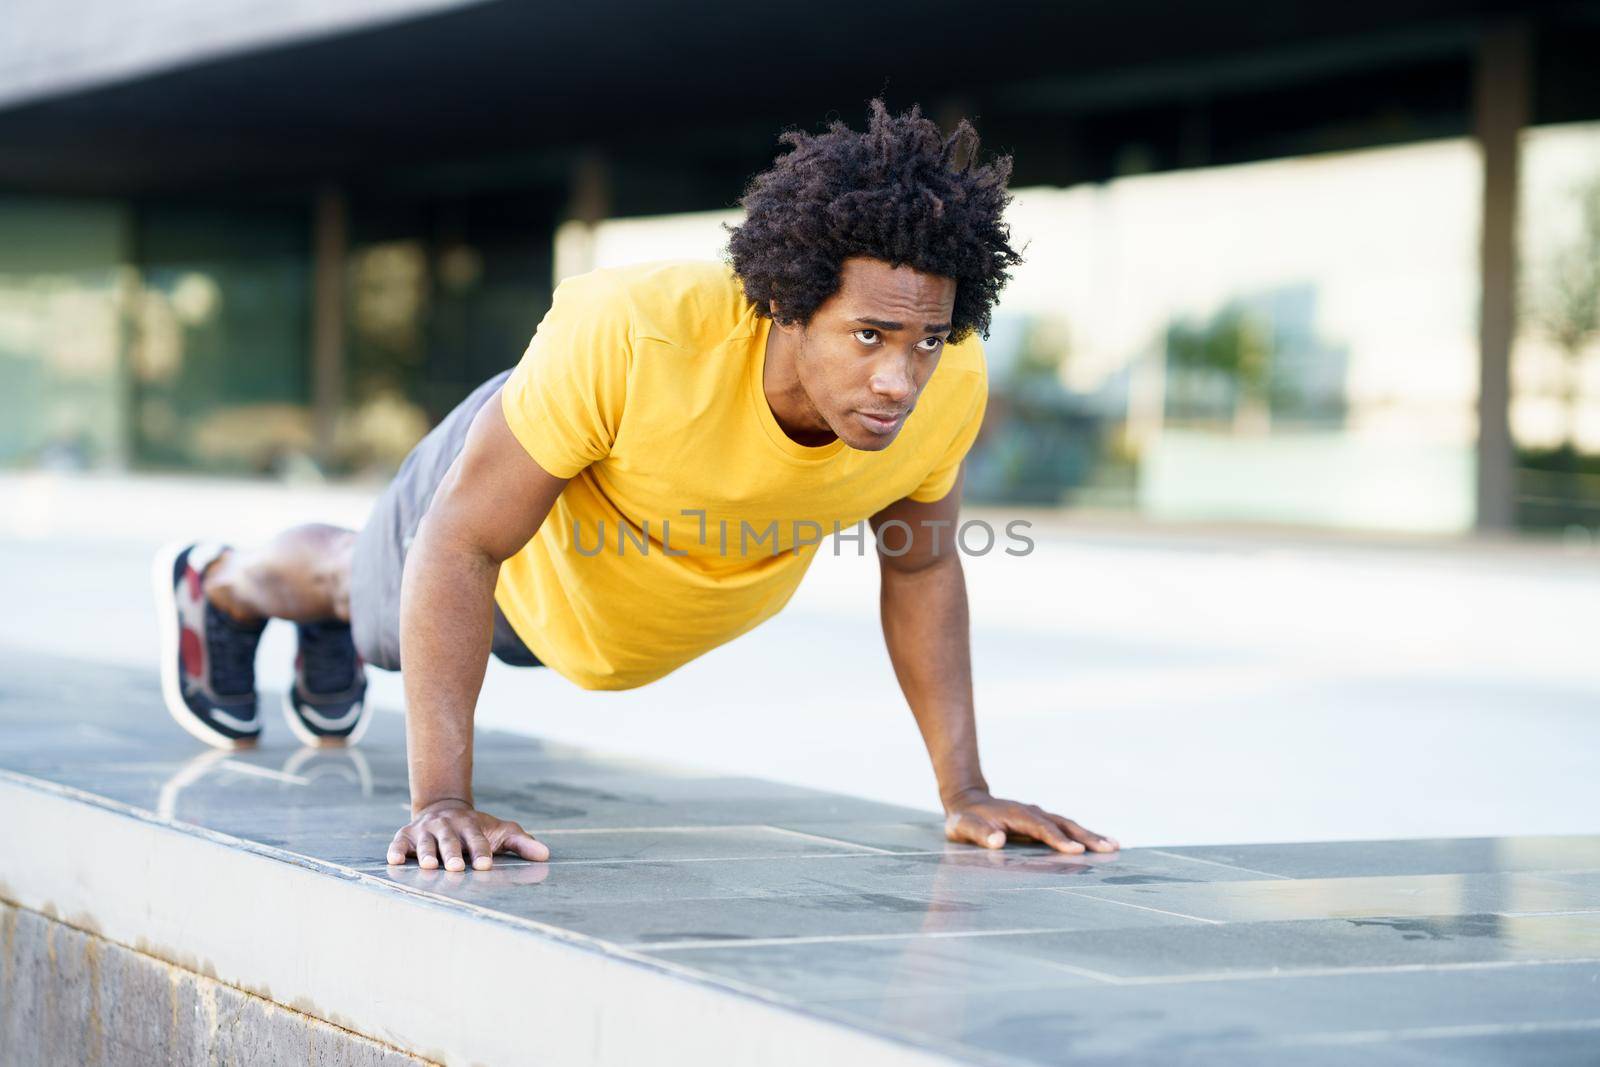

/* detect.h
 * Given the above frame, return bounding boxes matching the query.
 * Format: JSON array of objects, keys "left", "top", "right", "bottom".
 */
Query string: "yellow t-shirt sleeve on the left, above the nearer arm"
[{"left": 501, "top": 272, "right": 634, "bottom": 478}]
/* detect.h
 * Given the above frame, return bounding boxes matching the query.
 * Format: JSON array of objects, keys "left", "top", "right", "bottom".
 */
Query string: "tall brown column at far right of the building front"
[{"left": 1474, "top": 21, "right": 1533, "bottom": 533}]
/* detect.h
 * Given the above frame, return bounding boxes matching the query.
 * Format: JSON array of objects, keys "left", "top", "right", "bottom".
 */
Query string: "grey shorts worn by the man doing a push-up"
[{"left": 350, "top": 371, "right": 544, "bottom": 670}]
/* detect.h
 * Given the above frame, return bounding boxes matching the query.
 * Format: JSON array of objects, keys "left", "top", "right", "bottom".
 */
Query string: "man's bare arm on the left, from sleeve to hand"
[{"left": 389, "top": 394, "right": 566, "bottom": 870}]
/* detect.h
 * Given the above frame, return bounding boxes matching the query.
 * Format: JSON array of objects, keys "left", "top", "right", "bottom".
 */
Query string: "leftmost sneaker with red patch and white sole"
[{"left": 150, "top": 544, "right": 267, "bottom": 749}]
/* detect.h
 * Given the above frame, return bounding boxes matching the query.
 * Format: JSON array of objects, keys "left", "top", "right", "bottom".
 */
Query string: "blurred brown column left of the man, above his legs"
[{"left": 310, "top": 187, "right": 349, "bottom": 470}]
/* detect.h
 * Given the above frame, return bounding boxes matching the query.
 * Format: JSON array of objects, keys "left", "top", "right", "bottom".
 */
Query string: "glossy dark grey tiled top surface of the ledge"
[{"left": 0, "top": 653, "right": 1600, "bottom": 1064}]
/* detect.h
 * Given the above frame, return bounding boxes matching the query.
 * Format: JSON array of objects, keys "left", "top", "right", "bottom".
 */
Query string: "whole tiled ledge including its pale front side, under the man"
[{"left": 0, "top": 653, "right": 1600, "bottom": 1065}]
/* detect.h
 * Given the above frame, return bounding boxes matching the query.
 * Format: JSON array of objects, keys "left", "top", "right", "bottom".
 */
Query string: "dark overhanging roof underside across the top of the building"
[{"left": 0, "top": 0, "right": 1600, "bottom": 204}]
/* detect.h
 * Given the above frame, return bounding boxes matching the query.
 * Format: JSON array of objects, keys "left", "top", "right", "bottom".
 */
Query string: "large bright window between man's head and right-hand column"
[{"left": 970, "top": 141, "right": 1480, "bottom": 531}]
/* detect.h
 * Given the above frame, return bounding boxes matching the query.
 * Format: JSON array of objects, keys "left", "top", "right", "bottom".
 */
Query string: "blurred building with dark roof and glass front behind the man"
[{"left": 0, "top": 0, "right": 1600, "bottom": 537}]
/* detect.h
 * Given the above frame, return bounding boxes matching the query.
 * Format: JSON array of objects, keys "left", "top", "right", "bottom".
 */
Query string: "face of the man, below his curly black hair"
[{"left": 789, "top": 259, "right": 955, "bottom": 451}]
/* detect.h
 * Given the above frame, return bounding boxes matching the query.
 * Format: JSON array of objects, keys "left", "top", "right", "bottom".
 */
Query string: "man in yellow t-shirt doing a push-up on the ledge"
[{"left": 155, "top": 101, "right": 1118, "bottom": 870}]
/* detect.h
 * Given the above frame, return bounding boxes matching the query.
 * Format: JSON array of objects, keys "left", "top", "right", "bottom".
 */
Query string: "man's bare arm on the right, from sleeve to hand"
[{"left": 872, "top": 477, "right": 1117, "bottom": 853}]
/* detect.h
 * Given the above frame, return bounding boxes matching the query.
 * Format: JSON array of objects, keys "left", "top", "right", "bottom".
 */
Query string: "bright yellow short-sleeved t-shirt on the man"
[{"left": 494, "top": 262, "right": 989, "bottom": 689}]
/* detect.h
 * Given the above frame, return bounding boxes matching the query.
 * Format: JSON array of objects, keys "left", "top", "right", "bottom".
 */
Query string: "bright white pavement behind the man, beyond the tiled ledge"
[{"left": 0, "top": 475, "right": 1600, "bottom": 845}]
